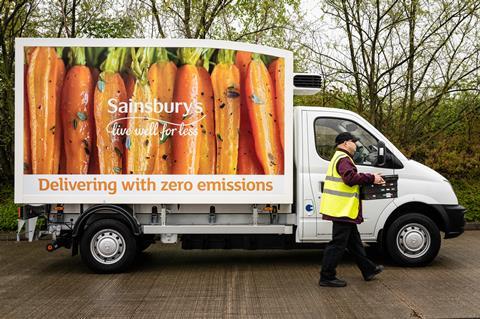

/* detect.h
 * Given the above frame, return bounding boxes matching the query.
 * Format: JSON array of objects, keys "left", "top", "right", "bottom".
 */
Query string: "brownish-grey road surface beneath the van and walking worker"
[{"left": 0, "top": 231, "right": 480, "bottom": 318}]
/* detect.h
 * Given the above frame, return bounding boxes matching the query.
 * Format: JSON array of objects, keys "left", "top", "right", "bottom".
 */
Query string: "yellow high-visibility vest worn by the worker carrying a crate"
[{"left": 320, "top": 151, "right": 360, "bottom": 219}]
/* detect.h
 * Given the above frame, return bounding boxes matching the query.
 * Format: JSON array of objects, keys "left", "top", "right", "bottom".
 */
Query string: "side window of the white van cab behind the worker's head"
[{"left": 314, "top": 118, "right": 378, "bottom": 166}]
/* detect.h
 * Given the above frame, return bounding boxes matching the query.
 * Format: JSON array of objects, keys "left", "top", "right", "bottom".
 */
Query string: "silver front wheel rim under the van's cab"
[{"left": 397, "top": 223, "right": 432, "bottom": 258}]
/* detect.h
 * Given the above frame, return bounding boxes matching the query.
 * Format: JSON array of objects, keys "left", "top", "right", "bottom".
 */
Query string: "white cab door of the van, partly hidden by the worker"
[{"left": 307, "top": 111, "right": 393, "bottom": 240}]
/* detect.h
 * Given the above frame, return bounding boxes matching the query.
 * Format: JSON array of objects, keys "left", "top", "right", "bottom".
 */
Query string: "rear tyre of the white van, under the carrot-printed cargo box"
[{"left": 80, "top": 219, "right": 137, "bottom": 273}]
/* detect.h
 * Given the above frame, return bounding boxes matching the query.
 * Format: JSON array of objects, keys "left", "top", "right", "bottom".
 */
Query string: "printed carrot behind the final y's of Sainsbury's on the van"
[{"left": 172, "top": 48, "right": 202, "bottom": 174}]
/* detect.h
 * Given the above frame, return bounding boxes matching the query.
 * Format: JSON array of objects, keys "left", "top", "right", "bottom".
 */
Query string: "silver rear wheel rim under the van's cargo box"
[{"left": 90, "top": 229, "right": 125, "bottom": 265}]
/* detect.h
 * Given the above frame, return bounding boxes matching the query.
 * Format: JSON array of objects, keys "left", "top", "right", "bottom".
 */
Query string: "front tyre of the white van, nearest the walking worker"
[{"left": 385, "top": 213, "right": 441, "bottom": 267}]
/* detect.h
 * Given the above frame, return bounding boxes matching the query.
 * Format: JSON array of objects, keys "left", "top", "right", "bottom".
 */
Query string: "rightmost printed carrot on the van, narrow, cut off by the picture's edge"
[{"left": 268, "top": 58, "right": 285, "bottom": 149}]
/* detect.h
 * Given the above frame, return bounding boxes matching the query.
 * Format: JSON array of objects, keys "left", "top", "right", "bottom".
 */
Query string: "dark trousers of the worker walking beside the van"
[{"left": 320, "top": 221, "right": 376, "bottom": 280}]
